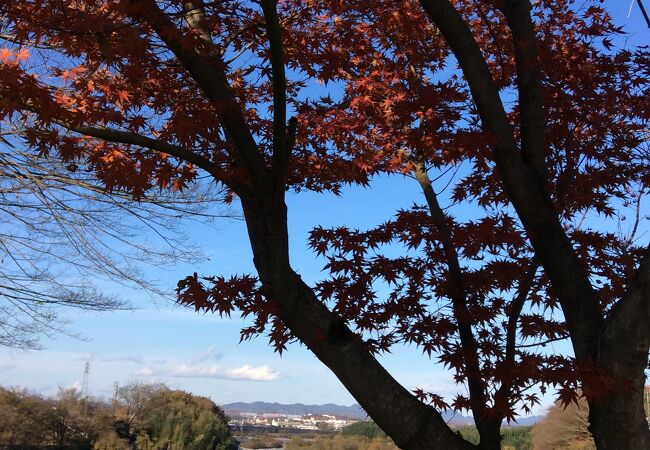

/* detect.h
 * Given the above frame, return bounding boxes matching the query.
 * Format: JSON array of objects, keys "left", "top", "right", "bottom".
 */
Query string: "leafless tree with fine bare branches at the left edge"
[{"left": 0, "top": 135, "right": 229, "bottom": 349}]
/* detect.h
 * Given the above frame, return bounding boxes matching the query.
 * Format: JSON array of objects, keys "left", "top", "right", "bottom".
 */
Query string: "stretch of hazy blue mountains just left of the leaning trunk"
[{"left": 221, "top": 402, "right": 368, "bottom": 419}]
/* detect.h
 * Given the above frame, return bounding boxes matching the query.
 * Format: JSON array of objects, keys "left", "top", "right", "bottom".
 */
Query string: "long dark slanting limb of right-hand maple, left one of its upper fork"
[{"left": 420, "top": 0, "right": 602, "bottom": 360}]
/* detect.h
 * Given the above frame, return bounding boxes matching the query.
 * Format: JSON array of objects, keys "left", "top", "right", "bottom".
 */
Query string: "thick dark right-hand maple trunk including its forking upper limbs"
[{"left": 420, "top": 0, "right": 650, "bottom": 450}]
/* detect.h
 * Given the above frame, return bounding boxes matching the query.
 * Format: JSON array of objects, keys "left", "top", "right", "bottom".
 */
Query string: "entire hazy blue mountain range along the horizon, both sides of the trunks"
[{"left": 221, "top": 402, "right": 542, "bottom": 427}]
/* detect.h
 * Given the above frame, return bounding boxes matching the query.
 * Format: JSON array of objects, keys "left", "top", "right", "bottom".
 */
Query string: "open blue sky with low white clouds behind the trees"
[{"left": 0, "top": 0, "right": 650, "bottom": 413}]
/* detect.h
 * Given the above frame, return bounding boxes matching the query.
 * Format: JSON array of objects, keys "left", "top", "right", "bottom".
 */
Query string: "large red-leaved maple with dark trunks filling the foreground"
[{"left": 0, "top": 0, "right": 650, "bottom": 449}]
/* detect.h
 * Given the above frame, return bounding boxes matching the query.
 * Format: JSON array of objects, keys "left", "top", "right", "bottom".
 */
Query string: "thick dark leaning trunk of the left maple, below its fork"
[{"left": 242, "top": 196, "right": 476, "bottom": 450}]
